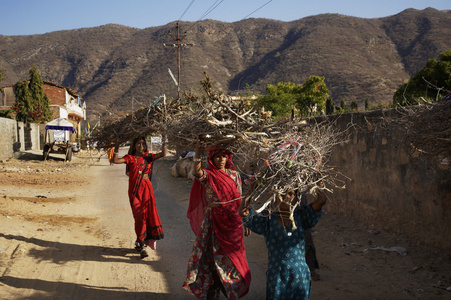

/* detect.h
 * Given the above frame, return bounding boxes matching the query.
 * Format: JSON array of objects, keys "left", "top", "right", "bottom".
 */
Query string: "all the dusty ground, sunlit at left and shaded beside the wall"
[{"left": 0, "top": 149, "right": 451, "bottom": 299}]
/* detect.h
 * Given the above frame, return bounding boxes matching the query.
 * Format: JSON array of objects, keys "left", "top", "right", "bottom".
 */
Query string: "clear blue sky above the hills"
[{"left": 0, "top": 0, "right": 451, "bottom": 35}]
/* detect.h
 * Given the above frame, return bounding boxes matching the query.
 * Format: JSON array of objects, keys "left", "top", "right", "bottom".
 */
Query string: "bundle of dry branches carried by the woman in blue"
[{"left": 240, "top": 121, "right": 343, "bottom": 226}]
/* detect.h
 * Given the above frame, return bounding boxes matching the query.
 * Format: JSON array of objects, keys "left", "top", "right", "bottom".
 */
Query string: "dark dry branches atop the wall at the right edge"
[{"left": 389, "top": 99, "right": 451, "bottom": 158}]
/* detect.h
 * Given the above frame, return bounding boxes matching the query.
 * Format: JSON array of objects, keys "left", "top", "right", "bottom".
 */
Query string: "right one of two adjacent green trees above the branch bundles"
[{"left": 296, "top": 76, "right": 329, "bottom": 115}]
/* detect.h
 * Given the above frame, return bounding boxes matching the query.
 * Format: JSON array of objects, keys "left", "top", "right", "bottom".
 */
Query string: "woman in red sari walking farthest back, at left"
[{"left": 113, "top": 135, "right": 167, "bottom": 258}]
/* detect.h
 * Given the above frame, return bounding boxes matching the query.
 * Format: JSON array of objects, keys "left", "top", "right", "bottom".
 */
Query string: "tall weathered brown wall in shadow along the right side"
[{"left": 318, "top": 111, "right": 451, "bottom": 248}]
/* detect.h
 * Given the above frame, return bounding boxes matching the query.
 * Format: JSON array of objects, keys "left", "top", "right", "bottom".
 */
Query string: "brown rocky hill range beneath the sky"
[{"left": 0, "top": 8, "right": 451, "bottom": 118}]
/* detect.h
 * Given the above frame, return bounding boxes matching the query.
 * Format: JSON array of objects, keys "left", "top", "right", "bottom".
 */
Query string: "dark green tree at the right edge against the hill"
[{"left": 393, "top": 50, "right": 451, "bottom": 106}]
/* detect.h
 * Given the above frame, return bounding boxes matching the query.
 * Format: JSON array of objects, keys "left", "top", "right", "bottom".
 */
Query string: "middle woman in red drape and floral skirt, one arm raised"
[{"left": 183, "top": 141, "right": 251, "bottom": 299}]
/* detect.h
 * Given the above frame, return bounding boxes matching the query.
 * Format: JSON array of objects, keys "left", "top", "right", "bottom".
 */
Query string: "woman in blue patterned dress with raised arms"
[{"left": 240, "top": 191, "right": 326, "bottom": 300}]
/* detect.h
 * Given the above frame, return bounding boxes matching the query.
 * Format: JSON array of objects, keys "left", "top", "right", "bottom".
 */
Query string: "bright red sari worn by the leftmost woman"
[{"left": 123, "top": 153, "right": 164, "bottom": 242}]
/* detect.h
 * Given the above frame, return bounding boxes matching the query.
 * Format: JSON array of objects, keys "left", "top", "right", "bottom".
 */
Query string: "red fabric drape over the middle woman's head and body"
[{"left": 187, "top": 149, "right": 251, "bottom": 288}]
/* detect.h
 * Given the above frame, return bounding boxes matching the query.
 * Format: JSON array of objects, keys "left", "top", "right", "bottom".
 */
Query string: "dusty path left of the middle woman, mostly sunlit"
[{"left": 0, "top": 149, "right": 264, "bottom": 299}]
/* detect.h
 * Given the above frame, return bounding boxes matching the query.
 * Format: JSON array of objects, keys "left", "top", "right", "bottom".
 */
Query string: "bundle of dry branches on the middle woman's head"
[{"left": 167, "top": 73, "right": 270, "bottom": 149}]
